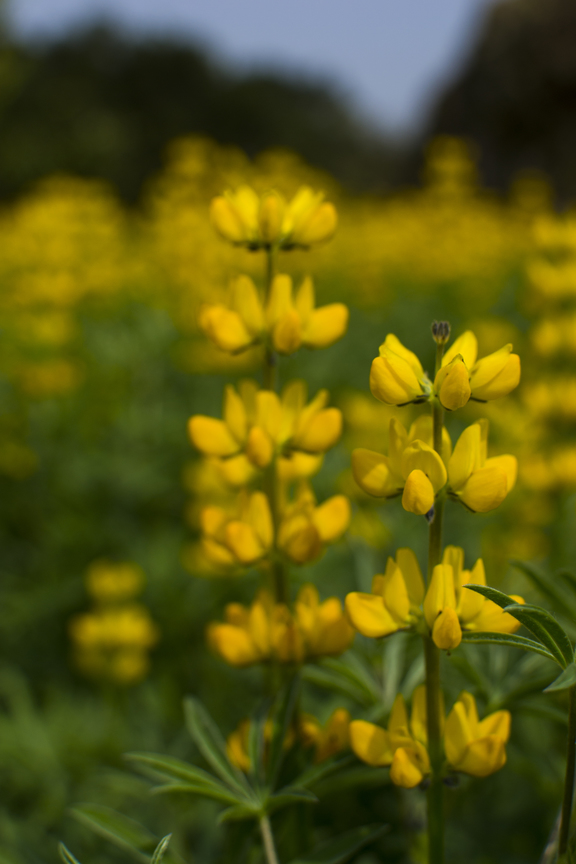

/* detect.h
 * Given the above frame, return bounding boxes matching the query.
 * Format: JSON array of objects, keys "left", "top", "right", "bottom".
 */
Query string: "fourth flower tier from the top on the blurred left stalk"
[{"left": 200, "top": 482, "right": 350, "bottom": 569}]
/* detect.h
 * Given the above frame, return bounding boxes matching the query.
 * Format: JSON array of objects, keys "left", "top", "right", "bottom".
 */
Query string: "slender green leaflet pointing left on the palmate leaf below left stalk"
[{"left": 126, "top": 753, "right": 250, "bottom": 804}]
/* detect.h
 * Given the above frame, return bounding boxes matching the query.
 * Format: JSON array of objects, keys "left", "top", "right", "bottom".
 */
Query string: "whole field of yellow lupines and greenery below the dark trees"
[{"left": 0, "top": 138, "right": 576, "bottom": 864}]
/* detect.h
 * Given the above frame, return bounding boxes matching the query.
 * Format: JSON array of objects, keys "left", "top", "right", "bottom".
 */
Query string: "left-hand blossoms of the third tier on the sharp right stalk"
[{"left": 346, "top": 549, "right": 424, "bottom": 638}]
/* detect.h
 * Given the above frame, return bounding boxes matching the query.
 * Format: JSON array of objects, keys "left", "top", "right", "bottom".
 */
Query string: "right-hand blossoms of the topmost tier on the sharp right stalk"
[{"left": 434, "top": 330, "right": 520, "bottom": 410}]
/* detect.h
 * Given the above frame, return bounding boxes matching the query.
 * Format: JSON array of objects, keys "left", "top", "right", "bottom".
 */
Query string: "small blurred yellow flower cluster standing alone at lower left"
[{"left": 69, "top": 561, "right": 159, "bottom": 685}]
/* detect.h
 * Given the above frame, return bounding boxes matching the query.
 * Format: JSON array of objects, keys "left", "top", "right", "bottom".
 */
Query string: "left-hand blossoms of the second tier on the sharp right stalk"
[{"left": 352, "top": 417, "right": 451, "bottom": 515}]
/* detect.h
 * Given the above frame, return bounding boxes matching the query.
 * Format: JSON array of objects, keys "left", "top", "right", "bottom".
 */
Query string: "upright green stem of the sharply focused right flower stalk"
[{"left": 424, "top": 334, "right": 445, "bottom": 864}]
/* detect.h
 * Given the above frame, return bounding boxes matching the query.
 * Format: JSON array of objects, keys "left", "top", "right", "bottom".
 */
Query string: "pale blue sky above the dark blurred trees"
[{"left": 8, "top": 0, "right": 494, "bottom": 132}]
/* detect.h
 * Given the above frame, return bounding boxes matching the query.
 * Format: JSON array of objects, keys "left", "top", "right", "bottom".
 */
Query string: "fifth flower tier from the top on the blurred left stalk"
[{"left": 208, "top": 585, "right": 354, "bottom": 666}]
